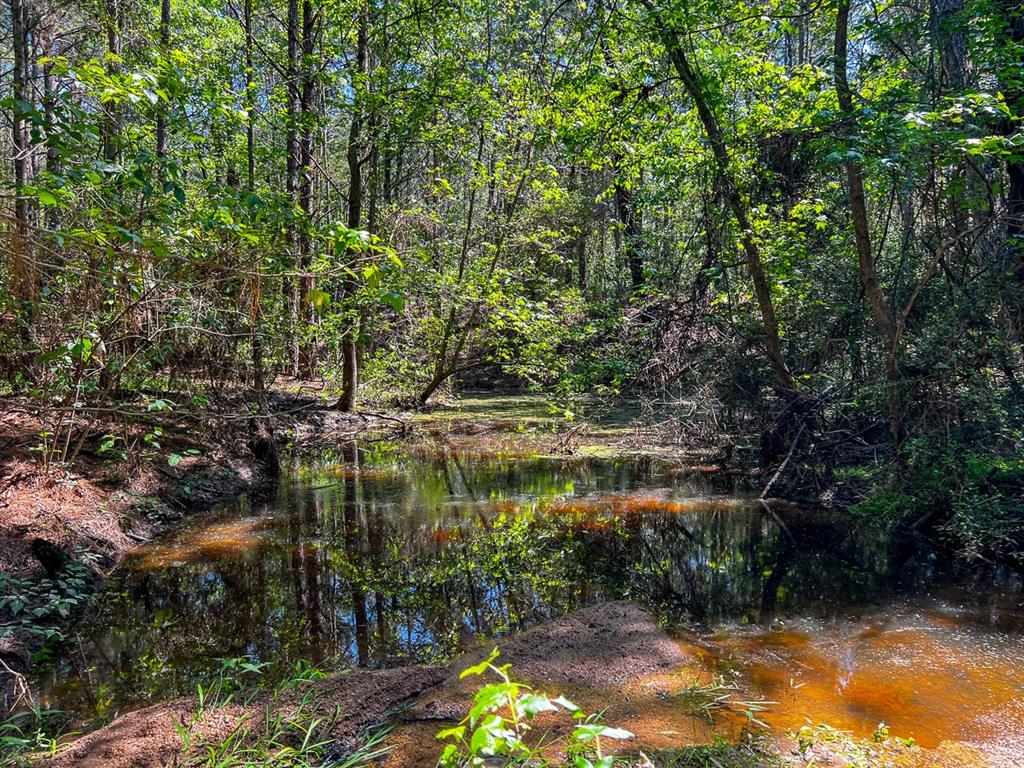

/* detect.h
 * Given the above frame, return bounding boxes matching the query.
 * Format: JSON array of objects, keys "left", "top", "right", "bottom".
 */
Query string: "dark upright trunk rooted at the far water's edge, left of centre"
[{"left": 338, "top": 7, "right": 370, "bottom": 412}]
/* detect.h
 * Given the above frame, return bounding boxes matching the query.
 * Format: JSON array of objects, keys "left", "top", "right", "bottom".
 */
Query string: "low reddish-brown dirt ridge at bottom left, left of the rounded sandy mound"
[{"left": 41, "top": 667, "right": 446, "bottom": 768}]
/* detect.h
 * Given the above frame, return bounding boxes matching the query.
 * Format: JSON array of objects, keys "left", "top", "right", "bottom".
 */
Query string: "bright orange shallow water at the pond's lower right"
[{"left": 706, "top": 611, "right": 1024, "bottom": 748}]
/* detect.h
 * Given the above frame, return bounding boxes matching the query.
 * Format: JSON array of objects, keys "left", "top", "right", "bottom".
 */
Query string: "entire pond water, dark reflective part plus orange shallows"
[{"left": 39, "top": 430, "right": 1024, "bottom": 745}]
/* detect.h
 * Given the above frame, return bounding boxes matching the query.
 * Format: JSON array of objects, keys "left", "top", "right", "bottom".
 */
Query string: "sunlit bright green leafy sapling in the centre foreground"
[{"left": 437, "top": 648, "right": 633, "bottom": 768}]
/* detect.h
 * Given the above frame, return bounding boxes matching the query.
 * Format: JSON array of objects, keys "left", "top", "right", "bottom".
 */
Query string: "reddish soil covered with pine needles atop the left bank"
[{"left": 0, "top": 391, "right": 398, "bottom": 575}]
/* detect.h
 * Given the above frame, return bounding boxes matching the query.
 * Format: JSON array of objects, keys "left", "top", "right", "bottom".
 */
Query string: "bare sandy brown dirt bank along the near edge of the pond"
[{"left": 36, "top": 602, "right": 1016, "bottom": 768}]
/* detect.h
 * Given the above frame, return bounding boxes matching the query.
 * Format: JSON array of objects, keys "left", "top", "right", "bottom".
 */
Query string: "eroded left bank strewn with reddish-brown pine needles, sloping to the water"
[{"left": 0, "top": 391, "right": 402, "bottom": 671}]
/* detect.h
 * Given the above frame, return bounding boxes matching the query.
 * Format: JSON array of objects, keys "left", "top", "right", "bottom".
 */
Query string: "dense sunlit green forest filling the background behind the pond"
[{"left": 0, "top": 0, "right": 1024, "bottom": 552}]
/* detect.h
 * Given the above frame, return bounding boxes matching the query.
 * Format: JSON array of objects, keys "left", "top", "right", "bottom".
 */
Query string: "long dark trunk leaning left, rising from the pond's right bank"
[{"left": 641, "top": 0, "right": 797, "bottom": 392}]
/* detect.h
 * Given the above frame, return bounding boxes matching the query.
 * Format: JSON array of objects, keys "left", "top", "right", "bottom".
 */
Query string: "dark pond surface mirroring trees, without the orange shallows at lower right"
[{"left": 36, "top": 442, "right": 1019, "bottom": 733}]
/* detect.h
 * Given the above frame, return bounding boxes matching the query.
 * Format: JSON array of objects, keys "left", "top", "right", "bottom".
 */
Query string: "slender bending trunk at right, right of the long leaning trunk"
[{"left": 834, "top": 0, "right": 903, "bottom": 447}]
